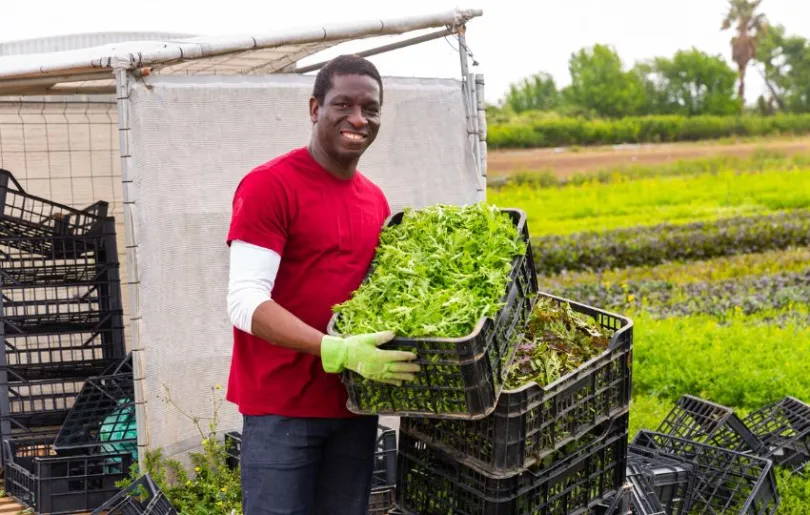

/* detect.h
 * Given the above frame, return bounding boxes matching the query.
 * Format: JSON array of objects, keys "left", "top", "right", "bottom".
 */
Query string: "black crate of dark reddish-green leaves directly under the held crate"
[{"left": 400, "top": 293, "right": 633, "bottom": 477}]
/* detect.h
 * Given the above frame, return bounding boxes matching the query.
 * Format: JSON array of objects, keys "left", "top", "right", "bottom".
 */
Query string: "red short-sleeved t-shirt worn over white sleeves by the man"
[{"left": 226, "top": 148, "right": 390, "bottom": 418}]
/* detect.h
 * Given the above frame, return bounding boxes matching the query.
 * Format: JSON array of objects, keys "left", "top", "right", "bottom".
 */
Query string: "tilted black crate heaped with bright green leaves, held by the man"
[{"left": 328, "top": 203, "right": 537, "bottom": 419}]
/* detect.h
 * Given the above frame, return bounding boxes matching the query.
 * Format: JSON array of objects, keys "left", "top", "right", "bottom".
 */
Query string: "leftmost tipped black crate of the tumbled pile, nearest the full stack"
[{"left": 627, "top": 456, "right": 696, "bottom": 515}]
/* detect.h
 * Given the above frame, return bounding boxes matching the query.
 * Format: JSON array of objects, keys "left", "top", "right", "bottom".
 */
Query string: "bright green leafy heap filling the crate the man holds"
[{"left": 334, "top": 203, "right": 526, "bottom": 338}]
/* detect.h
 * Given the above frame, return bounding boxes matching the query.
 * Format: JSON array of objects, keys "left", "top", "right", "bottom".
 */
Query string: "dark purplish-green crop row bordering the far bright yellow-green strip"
[{"left": 532, "top": 210, "right": 810, "bottom": 275}]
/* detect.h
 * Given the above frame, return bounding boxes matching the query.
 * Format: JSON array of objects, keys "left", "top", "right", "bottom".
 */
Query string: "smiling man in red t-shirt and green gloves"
[{"left": 227, "top": 55, "right": 419, "bottom": 515}]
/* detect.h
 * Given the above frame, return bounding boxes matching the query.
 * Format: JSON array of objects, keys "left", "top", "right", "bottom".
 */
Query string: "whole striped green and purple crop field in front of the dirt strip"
[{"left": 488, "top": 152, "right": 810, "bottom": 514}]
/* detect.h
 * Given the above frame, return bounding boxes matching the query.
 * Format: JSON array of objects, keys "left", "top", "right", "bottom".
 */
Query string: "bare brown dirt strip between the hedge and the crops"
[{"left": 487, "top": 137, "right": 810, "bottom": 177}]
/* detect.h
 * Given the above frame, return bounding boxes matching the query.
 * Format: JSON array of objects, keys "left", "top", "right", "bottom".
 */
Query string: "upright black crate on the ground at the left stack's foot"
[{"left": 3, "top": 436, "right": 132, "bottom": 514}]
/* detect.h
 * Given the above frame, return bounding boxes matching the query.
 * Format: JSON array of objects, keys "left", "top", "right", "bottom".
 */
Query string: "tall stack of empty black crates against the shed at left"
[{"left": 0, "top": 170, "right": 133, "bottom": 513}]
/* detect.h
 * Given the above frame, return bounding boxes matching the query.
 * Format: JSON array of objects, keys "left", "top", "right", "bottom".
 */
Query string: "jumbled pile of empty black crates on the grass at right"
[{"left": 628, "top": 395, "right": 796, "bottom": 515}]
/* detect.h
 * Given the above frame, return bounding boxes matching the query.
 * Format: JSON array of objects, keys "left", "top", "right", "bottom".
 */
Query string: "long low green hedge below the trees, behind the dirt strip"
[{"left": 487, "top": 114, "right": 810, "bottom": 149}]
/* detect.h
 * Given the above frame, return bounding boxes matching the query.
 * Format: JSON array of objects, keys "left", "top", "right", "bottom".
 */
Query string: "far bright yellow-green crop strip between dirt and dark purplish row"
[{"left": 487, "top": 162, "right": 810, "bottom": 236}]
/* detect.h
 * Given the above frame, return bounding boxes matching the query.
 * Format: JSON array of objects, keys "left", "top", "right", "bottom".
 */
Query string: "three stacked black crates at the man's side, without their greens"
[{"left": 328, "top": 209, "right": 633, "bottom": 515}]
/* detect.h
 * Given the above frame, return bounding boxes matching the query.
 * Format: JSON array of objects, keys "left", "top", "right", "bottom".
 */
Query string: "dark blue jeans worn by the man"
[{"left": 239, "top": 415, "right": 378, "bottom": 515}]
